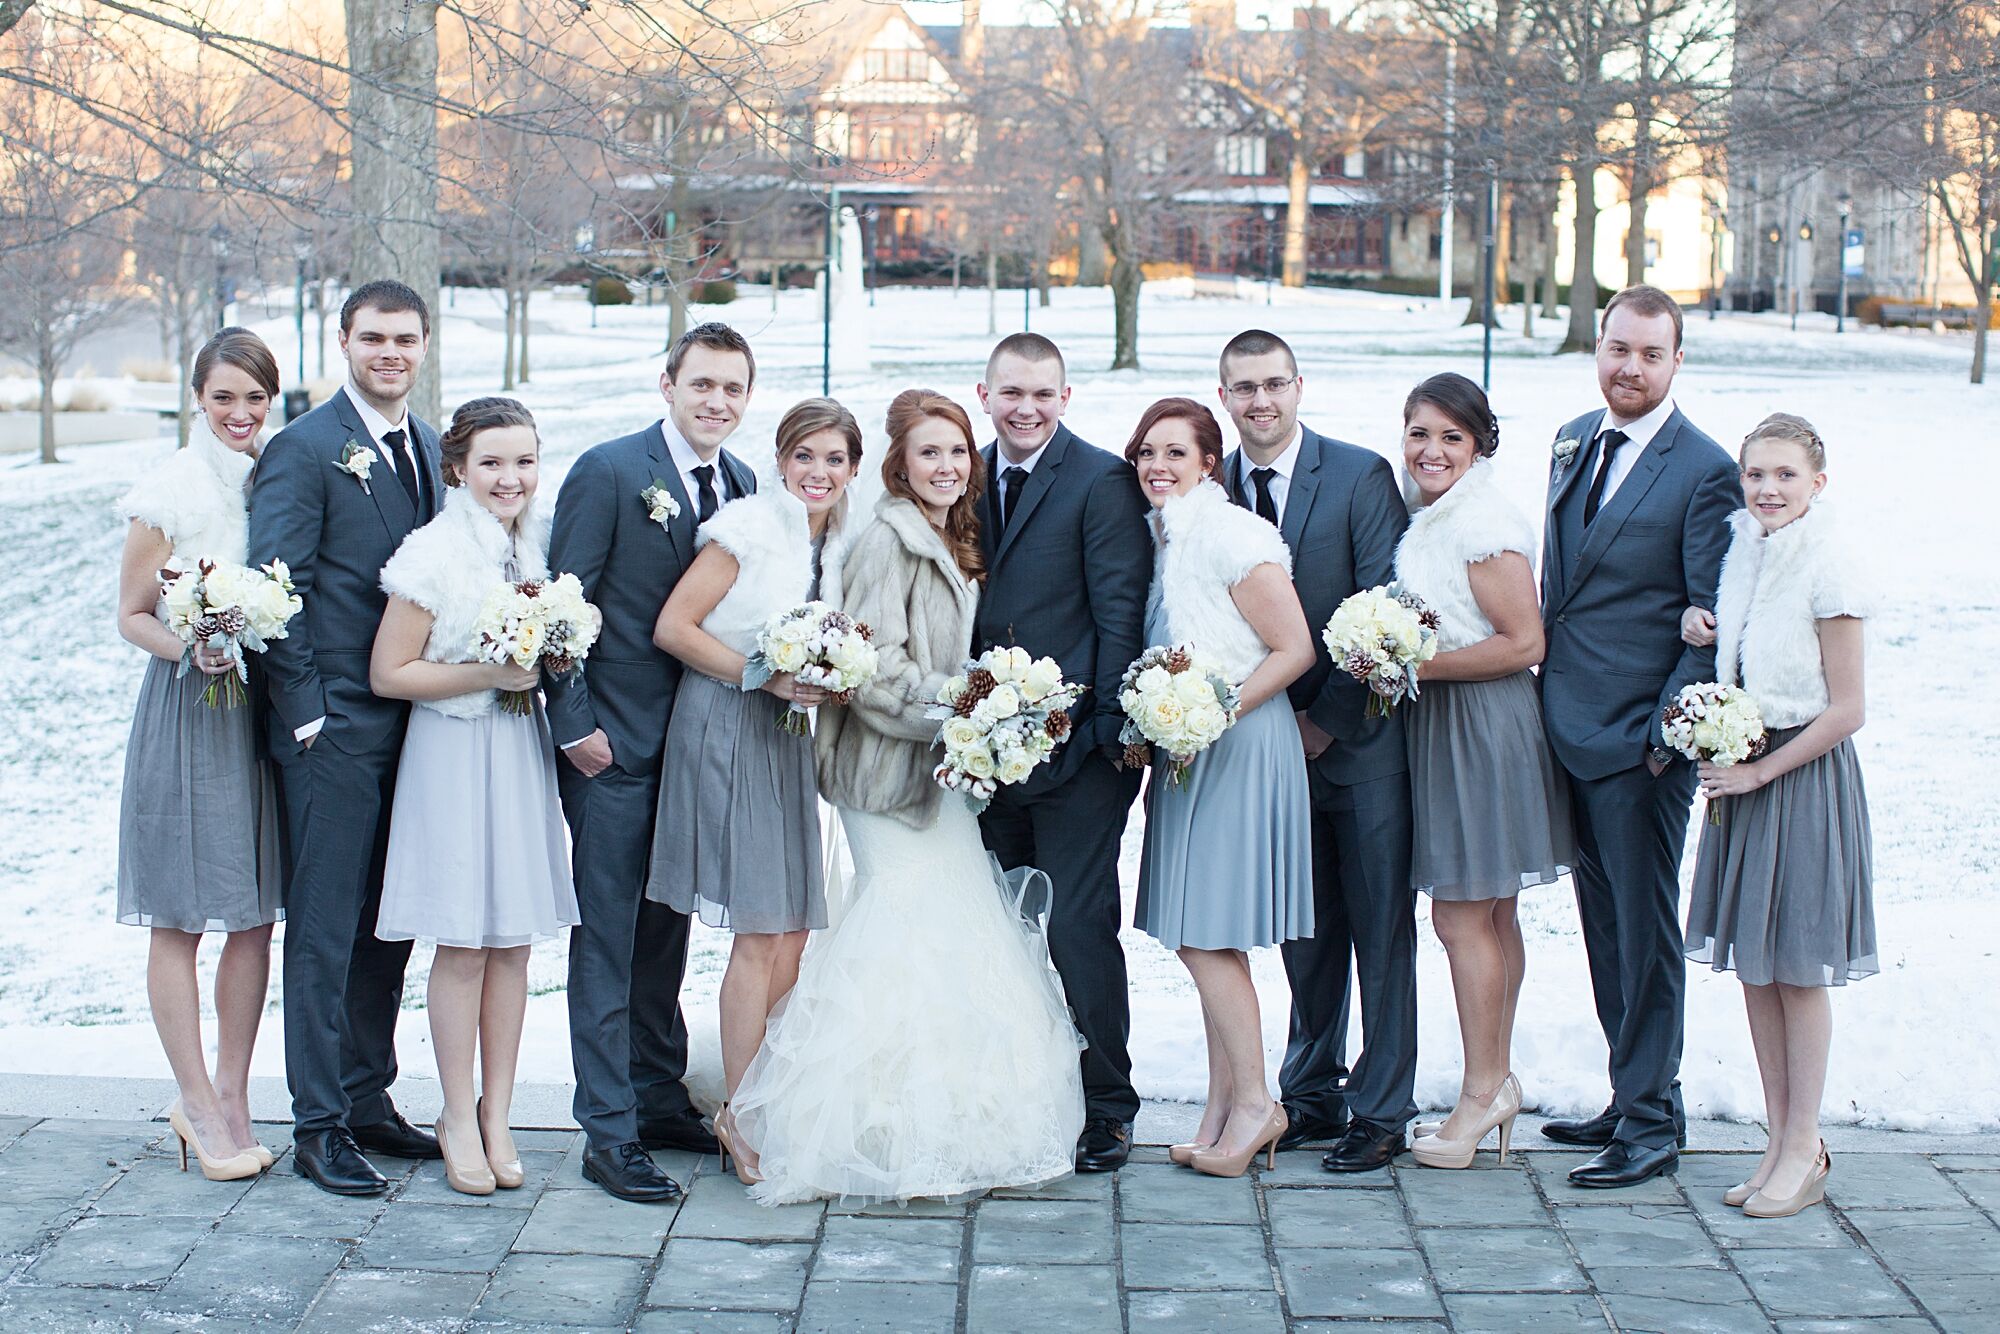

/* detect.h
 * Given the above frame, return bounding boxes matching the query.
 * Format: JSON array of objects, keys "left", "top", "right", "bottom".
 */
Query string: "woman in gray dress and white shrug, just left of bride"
[{"left": 646, "top": 398, "right": 862, "bottom": 1184}]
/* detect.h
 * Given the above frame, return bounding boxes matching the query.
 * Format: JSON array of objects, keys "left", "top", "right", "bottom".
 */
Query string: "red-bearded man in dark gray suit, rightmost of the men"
[{"left": 1542, "top": 286, "right": 1742, "bottom": 1186}]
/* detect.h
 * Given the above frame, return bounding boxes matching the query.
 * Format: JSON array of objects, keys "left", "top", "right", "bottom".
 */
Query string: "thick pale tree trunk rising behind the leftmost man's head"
[{"left": 346, "top": 0, "right": 444, "bottom": 422}]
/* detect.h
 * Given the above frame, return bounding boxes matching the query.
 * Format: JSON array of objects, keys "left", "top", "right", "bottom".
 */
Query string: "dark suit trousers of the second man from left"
[{"left": 556, "top": 756, "right": 692, "bottom": 1148}]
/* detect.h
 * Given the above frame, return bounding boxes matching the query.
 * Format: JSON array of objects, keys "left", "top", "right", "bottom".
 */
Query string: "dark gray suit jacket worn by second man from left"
[{"left": 544, "top": 422, "right": 756, "bottom": 774}]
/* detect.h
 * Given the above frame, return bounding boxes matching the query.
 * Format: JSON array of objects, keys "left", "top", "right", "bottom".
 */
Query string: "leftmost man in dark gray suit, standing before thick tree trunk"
[{"left": 250, "top": 280, "right": 444, "bottom": 1196}]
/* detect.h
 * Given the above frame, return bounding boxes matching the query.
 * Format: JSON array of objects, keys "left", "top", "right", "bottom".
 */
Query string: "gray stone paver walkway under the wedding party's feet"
[{"left": 0, "top": 1118, "right": 2000, "bottom": 1334}]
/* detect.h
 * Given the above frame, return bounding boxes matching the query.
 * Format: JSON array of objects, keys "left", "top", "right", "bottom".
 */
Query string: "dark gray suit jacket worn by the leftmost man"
[{"left": 250, "top": 386, "right": 444, "bottom": 754}]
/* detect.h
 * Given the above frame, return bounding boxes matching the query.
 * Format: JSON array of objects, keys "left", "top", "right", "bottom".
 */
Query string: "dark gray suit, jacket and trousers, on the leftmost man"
[{"left": 250, "top": 388, "right": 444, "bottom": 1134}]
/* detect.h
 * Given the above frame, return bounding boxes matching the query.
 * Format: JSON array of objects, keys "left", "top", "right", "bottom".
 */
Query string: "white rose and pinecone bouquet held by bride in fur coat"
[{"left": 930, "top": 648, "right": 1084, "bottom": 814}]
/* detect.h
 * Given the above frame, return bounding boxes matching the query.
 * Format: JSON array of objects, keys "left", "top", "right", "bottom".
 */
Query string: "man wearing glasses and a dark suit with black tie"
[{"left": 1218, "top": 328, "right": 1416, "bottom": 1172}]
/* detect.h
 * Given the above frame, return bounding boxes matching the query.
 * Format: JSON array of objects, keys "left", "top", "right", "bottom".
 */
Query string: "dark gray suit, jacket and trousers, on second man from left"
[{"left": 546, "top": 422, "right": 756, "bottom": 1148}]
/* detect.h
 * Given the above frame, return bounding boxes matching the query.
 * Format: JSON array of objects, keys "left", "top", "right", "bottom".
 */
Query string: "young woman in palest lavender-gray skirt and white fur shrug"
[{"left": 368, "top": 398, "right": 576, "bottom": 1194}]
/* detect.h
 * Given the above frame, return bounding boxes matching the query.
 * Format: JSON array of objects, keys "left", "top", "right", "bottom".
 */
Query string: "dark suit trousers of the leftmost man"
[{"left": 276, "top": 726, "right": 410, "bottom": 1134}]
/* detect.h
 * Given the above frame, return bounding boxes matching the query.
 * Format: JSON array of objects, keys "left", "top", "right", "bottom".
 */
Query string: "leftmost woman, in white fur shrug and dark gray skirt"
[{"left": 118, "top": 328, "right": 284, "bottom": 1180}]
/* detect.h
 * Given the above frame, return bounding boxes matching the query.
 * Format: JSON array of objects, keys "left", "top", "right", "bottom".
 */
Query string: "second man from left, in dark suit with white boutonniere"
[{"left": 546, "top": 324, "right": 756, "bottom": 1204}]
